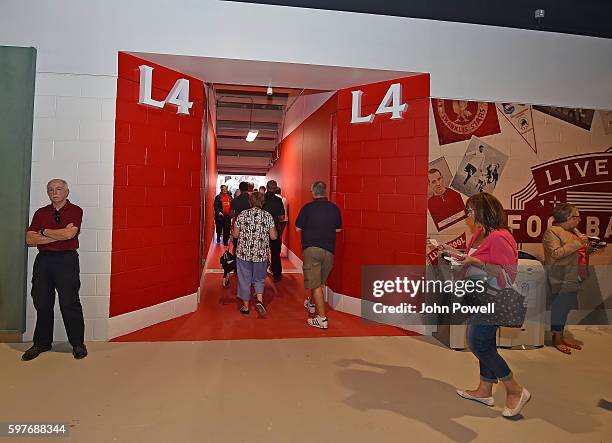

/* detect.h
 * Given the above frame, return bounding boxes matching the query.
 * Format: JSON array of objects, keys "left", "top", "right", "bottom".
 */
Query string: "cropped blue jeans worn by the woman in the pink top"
[{"left": 468, "top": 319, "right": 512, "bottom": 383}]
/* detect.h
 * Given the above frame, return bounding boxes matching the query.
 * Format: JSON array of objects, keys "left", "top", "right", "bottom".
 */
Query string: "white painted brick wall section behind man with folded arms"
[{"left": 23, "top": 73, "right": 117, "bottom": 341}]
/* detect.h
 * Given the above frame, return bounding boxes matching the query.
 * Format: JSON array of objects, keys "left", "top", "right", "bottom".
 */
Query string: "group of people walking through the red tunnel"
[{"left": 214, "top": 180, "right": 342, "bottom": 329}]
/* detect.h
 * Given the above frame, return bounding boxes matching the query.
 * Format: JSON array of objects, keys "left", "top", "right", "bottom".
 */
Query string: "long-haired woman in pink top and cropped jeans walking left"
[{"left": 444, "top": 192, "right": 531, "bottom": 417}]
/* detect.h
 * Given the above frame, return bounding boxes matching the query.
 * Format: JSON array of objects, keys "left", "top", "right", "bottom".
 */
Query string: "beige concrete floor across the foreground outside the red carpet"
[{"left": 0, "top": 327, "right": 612, "bottom": 443}]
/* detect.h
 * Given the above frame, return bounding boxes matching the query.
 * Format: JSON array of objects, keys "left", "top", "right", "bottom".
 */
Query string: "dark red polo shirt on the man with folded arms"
[{"left": 27, "top": 200, "right": 83, "bottom": 251}]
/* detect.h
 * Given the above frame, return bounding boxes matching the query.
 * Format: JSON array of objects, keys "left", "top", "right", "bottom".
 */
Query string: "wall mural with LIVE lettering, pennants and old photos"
[{"left": 428, "top": 99, "right": 612, "bottom": 264}]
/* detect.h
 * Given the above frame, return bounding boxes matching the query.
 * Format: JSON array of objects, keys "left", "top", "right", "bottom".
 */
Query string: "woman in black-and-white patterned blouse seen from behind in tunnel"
[{"left": 232, "top": 192, "right": 278, "bottom": 317}]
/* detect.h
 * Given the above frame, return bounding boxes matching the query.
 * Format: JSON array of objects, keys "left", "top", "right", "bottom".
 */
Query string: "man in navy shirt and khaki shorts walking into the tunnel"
[{"left": 295, "top": 181, "right": 342, "bottom": 329}]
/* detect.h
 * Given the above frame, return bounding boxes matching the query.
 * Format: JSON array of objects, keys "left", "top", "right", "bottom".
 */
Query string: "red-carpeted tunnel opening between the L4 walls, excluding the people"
[{"left": 115, "top": 53, "right": 426, "bottom": 341}]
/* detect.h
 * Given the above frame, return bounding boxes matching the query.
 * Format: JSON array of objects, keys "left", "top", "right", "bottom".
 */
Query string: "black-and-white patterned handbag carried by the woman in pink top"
[{"left": 464, "top": 269, "right": 527, "bottom": 328}]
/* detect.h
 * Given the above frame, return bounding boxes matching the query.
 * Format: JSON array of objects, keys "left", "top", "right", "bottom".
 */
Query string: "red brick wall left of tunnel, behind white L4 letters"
[{"left": 110, "top": 53, "right": 205, "bottom": 317}]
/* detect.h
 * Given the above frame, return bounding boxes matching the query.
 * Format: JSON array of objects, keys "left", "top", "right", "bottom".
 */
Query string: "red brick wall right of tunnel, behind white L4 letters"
[{"left": 328, "top": 75, "right": 429, "bottom": 297}]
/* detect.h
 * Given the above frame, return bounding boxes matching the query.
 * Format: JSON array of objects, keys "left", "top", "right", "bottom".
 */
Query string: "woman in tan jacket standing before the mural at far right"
[{"left": 542, "top": 203, "right": 589, "bottom": 354}]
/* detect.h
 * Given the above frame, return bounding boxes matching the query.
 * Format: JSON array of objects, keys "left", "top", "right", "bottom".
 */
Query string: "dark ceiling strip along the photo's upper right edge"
[{"left": 230, "top": 0, "right": 612, "bottom": 38}]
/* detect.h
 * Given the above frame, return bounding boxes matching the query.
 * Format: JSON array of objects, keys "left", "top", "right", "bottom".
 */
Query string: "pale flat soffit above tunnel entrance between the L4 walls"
[{"left": 130, "top": 52, "right": 415, "bottom": 91}]
